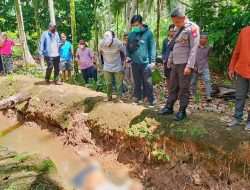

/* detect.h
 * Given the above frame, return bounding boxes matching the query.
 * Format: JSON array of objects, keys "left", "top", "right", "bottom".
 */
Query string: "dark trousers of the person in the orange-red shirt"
[{"left": 234, "top": 75, "right": 250, "bottom": 122}]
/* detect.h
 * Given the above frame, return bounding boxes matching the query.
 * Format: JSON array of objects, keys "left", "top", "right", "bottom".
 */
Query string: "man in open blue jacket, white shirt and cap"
[{"left": 39, "top": 22, "right": 60, "bottom": 85}]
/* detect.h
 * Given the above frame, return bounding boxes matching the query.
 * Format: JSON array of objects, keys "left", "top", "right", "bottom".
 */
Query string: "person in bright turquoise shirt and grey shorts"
[{"left": 59, "top": 33, "right": 73, "bottom": 81}]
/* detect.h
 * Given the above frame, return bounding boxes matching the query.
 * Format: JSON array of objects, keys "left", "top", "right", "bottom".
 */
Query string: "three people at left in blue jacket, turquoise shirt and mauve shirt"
[{"left": 39, "top": 22, "right": 97, "bottom": 85}]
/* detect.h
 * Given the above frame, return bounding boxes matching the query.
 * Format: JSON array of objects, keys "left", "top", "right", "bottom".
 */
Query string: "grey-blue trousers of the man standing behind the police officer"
[{"left": 191, "top": 69, "right": 212, "bottom": 98}]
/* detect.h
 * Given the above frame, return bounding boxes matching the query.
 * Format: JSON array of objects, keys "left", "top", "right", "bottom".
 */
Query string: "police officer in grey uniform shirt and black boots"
[{"left": 158, "top": 8, "right": 200, "bottom": 121}]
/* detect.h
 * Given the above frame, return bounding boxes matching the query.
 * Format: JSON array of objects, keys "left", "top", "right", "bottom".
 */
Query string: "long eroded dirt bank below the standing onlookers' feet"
[{"left": 0, "top": 76, "right": 250, "bottom": 189}]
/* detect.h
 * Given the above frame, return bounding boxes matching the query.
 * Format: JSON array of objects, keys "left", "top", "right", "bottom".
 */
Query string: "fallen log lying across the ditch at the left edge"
[{"left": 0, "top": 93, "right": 31, "bottom": 111}]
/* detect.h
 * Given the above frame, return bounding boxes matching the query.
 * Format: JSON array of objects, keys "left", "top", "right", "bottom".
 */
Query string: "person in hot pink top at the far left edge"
[{"left": 0, "top": 32, "right": 15, "bottom": 74}]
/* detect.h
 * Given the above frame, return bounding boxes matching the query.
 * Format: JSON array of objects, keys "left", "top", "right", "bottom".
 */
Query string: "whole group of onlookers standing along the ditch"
[{"left": 0, "top": 8, "right": 250, "bottom": 130}]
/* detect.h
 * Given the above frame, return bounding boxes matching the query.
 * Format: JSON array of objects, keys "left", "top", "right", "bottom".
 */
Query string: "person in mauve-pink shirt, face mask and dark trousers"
[{"left": 76, "top": 40, "right": 97, "bottom": 87}]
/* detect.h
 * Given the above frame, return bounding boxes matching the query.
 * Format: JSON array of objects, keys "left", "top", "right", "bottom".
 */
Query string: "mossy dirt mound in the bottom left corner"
[{"left": 0, "top": 147, "right": 73, "bottom": 190}]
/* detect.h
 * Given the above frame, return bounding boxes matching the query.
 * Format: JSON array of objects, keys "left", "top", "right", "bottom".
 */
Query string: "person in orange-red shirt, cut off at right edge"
[{"left": 228, "top": 26, "right": 250, "bottom": 131}]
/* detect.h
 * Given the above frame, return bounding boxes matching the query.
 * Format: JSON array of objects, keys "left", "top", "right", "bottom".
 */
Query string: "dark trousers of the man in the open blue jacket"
[{"left": 45, "top": 56, "right": 60, "bottom": 81}]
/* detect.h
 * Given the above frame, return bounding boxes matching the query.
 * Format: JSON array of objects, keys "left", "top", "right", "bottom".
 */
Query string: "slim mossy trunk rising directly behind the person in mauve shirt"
[{"left": 70, "top": 0, "right": 78, "bottom": 74}]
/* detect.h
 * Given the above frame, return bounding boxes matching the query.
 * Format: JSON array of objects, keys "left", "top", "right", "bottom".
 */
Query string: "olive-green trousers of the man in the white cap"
[{"left": 104, "top": 71, "right": 122, "bottom": 98}]
